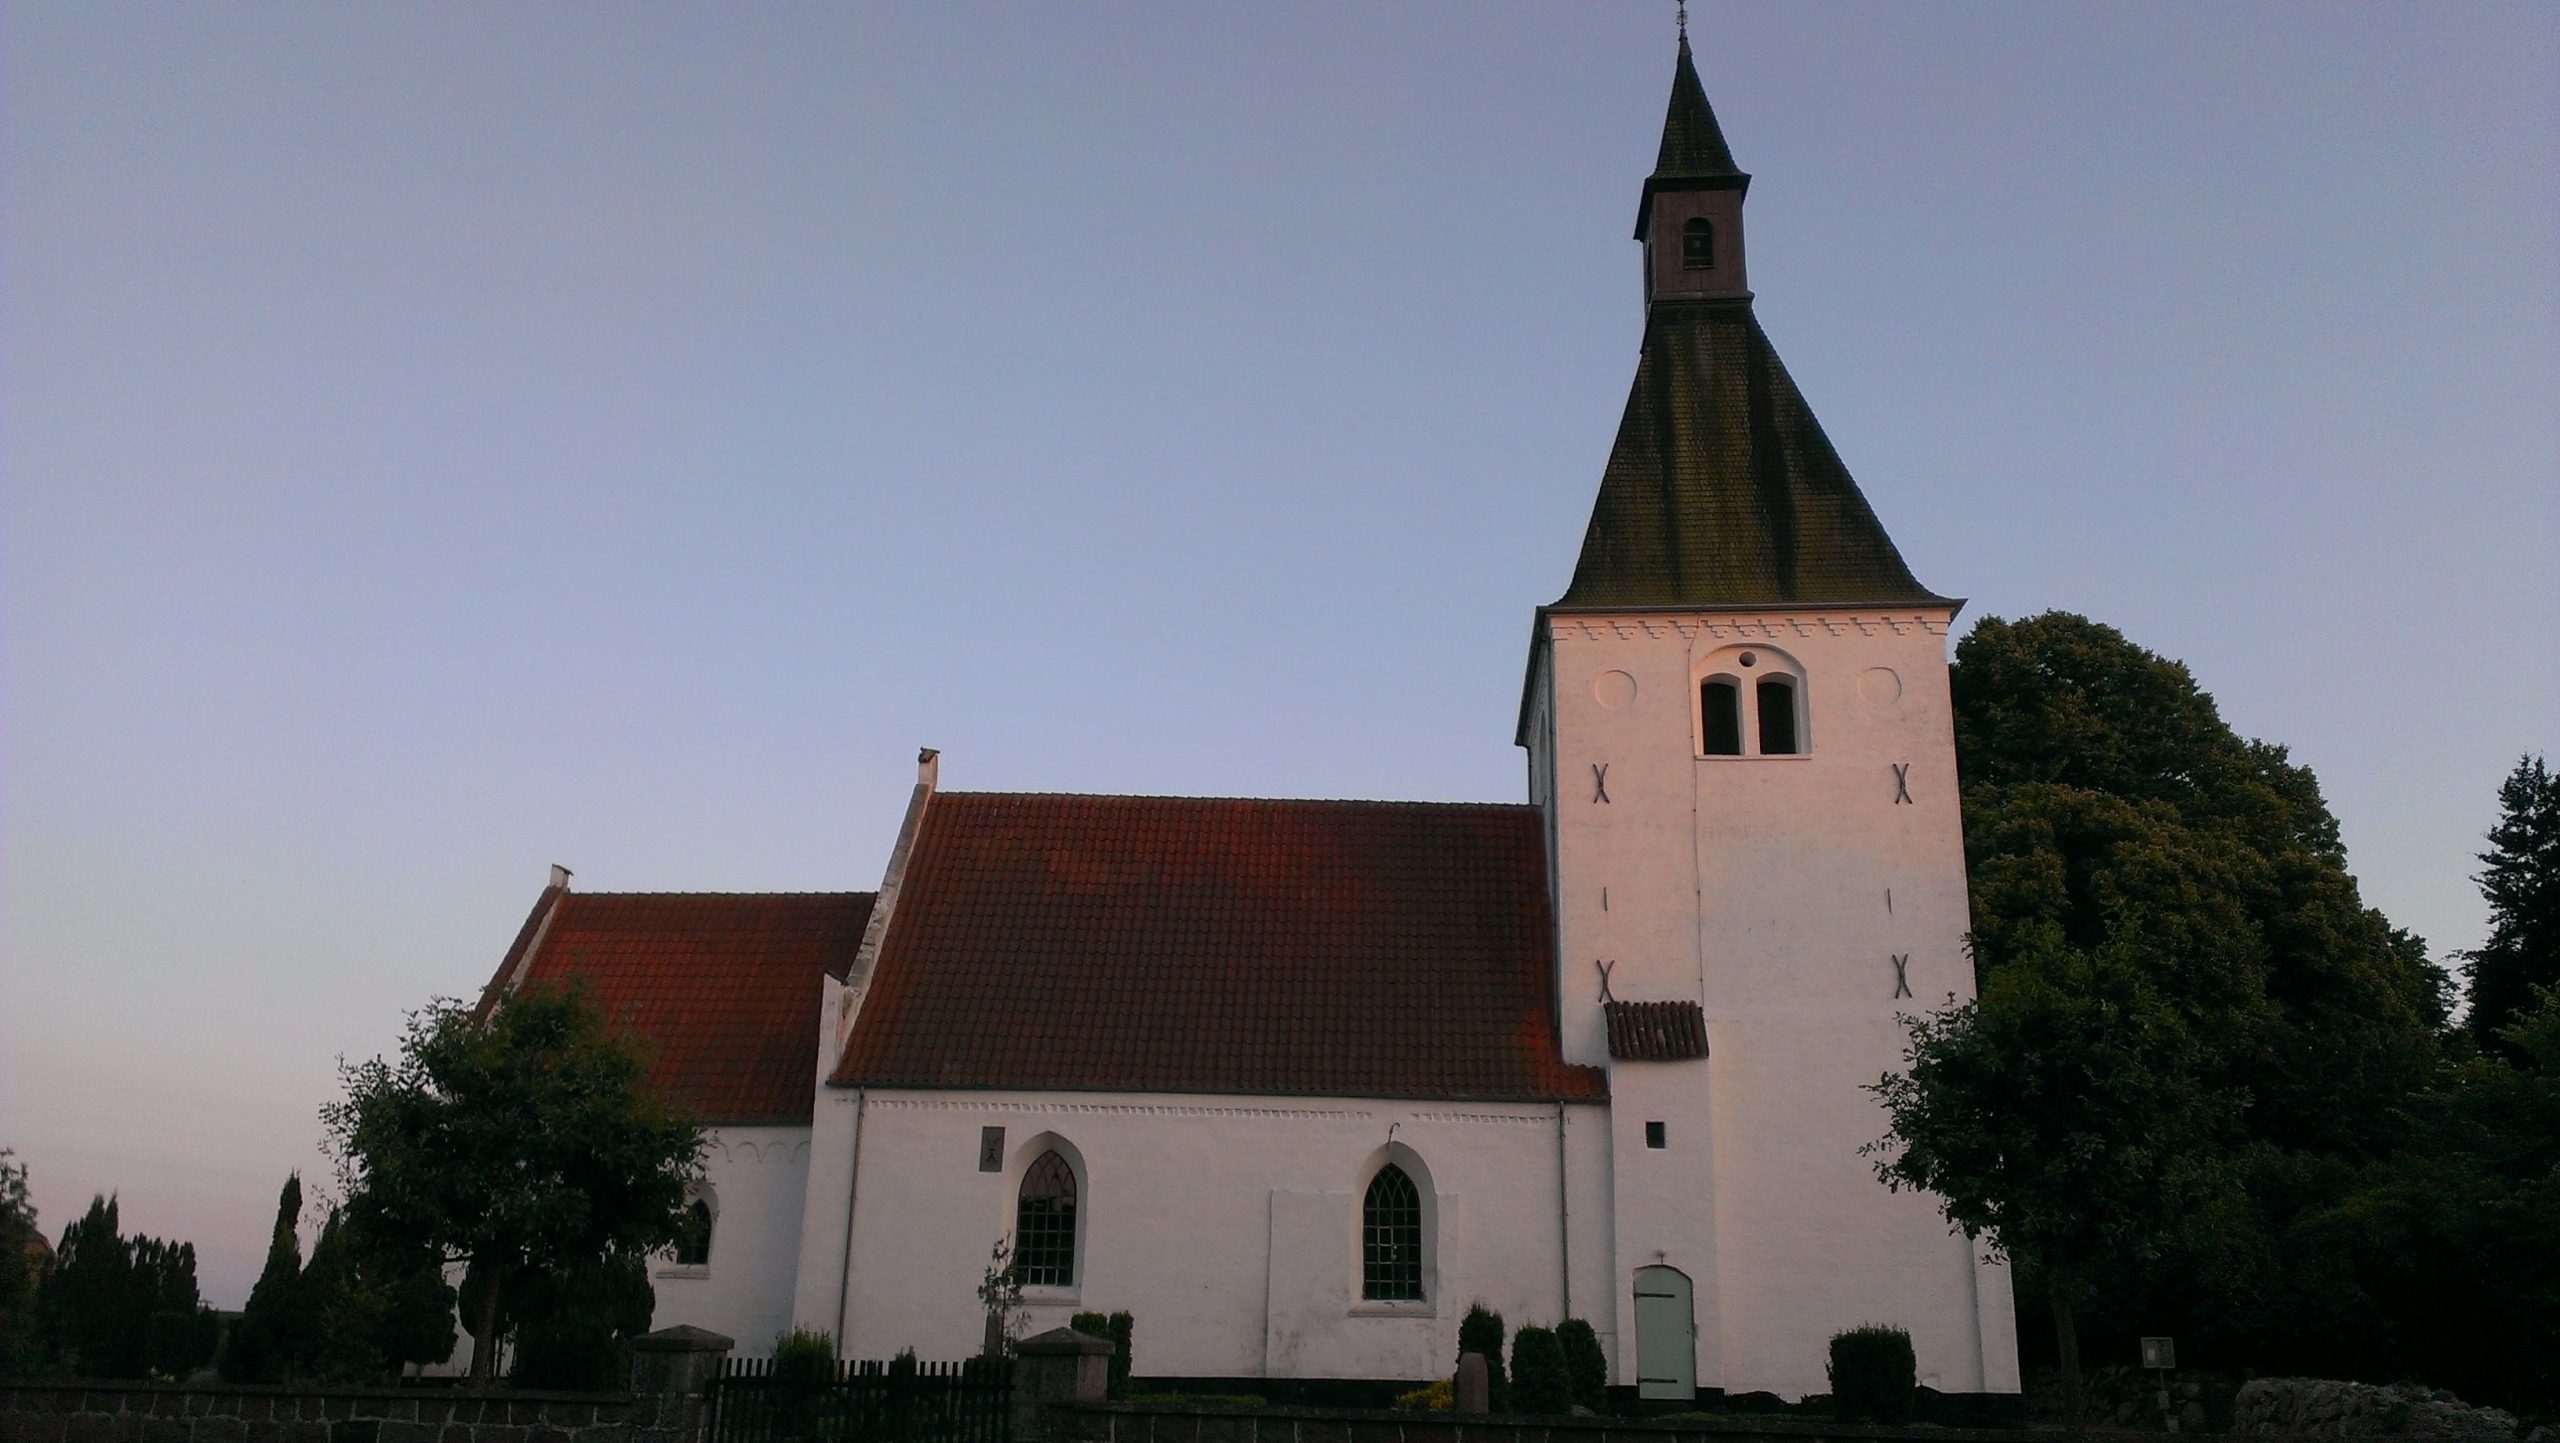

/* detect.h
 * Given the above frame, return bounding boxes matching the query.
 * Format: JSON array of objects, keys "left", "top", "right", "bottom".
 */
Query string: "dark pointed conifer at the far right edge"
[{"left": 2463, "top": 757, "right": 2560, "bottom": 1046}]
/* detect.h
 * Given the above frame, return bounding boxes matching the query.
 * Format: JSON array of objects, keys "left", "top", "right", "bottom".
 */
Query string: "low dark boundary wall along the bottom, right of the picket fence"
[{"left": 1049, "top": 1402, "right": 2514, "bottom": 1443}]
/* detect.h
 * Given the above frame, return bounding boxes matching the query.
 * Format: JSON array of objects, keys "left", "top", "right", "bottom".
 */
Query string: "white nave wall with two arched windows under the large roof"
[{"left": 801, "top": 1090, "right": 1608, "bottom": 1379}]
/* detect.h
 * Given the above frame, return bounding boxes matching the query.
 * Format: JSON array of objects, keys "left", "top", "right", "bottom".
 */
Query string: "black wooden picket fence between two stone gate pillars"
[{"left": 704, "top": 1359, "right": 1014, "bottom": 1443}]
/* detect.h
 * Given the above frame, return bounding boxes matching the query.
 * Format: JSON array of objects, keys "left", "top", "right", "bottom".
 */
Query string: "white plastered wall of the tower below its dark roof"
[{"left": 1528, "top": 611, "right": 2017, "bottom": 1397}]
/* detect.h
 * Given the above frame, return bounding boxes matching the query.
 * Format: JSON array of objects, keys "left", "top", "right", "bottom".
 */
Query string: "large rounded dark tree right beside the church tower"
[{"left": 1884, "top": 614, "right": 2445, "bottom": 1412}]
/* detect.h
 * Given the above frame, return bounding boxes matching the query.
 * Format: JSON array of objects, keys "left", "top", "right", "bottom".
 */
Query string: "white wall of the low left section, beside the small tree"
[{"left": 650, "top": 1126, "right": 809, "bottom": 1356}]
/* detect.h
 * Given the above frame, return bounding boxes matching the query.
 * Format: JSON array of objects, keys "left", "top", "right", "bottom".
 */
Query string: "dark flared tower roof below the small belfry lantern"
[{"left": 1556, "top": 302, "right": 1953, "bottom": 609}]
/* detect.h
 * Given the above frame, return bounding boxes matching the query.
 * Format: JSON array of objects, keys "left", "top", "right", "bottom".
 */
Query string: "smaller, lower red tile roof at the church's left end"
[{"left": 499, "top": 893, "right": 870, "bottom": 1123}]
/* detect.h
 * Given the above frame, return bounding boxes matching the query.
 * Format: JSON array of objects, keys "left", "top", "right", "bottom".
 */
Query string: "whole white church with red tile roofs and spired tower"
[{"left": 476, "top": 41, "right": 2017, "bottom": 1400}]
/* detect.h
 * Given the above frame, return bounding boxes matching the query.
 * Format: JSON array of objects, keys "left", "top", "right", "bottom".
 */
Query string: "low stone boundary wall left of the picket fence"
[{"left": 0, "top": 1382, "right": 699, "bottom": 1443}]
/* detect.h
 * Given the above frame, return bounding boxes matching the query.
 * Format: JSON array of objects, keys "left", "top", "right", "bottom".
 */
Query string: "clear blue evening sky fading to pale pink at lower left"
[{"left": 0, "top": 0, "right": 2560, "bottom": 1305}]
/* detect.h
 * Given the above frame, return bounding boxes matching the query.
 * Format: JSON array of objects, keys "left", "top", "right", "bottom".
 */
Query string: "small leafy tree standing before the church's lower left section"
[{"left": 323, "top": 988, "right": 701, "bottom": 1379}]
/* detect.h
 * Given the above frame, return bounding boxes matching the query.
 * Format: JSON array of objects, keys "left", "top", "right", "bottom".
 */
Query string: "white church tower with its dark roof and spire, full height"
[{"left": 1518, "top": 38, "right": 2017, "bottom": 1397}]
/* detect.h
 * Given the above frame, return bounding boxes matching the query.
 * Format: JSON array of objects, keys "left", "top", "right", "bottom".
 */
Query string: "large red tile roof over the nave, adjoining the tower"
[{"left": 835, "top": 793, "right": 1608, "bottom": 1100}]
